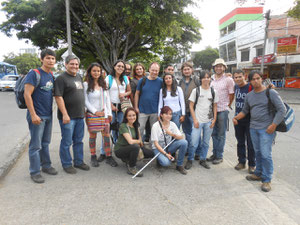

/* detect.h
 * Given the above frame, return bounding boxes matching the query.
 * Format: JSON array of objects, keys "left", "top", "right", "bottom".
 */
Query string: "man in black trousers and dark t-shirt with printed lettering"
[{"left": 233, "top": 70, "right": 255, "bottom": 174}]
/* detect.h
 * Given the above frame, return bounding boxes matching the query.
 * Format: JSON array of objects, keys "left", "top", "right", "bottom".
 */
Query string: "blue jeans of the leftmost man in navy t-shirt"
[{"left": 26, "top": 111, "right": 52, "bottom": 175}]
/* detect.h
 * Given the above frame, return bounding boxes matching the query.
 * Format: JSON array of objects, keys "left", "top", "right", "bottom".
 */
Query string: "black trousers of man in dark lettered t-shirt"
[{"left": 234, "top": 122, "right": 255, "bottom": 167}]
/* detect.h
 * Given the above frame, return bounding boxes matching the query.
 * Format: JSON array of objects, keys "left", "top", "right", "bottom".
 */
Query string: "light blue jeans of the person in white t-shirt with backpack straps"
[{"left": 188, "top": 122, "right": 213, "bottom": 160}]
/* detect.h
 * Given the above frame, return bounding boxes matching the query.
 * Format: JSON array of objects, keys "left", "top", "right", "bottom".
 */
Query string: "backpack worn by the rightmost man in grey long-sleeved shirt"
[{"left": 266, "top": 88, "right": 295, "bottom": 132}]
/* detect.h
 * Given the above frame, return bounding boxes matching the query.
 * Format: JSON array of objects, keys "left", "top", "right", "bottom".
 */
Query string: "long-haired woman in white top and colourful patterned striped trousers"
[{"left": 83, "top": 63, "right": 118, "bottom": 167}]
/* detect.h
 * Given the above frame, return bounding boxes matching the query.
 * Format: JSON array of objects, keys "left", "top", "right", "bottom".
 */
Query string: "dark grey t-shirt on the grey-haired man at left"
[{"left": 54, "top": 72, "right": 85, "bottom": 120}]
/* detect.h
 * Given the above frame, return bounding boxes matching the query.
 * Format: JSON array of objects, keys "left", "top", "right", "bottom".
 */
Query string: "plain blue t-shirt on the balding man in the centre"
[{"left": 137, "top": 77, "right": 163, "bottom": 114}]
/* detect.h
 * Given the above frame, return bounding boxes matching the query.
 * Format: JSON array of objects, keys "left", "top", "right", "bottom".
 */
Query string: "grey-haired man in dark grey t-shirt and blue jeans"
[{"left": 54, "top": 55, "right": 90, "bottom": 174}]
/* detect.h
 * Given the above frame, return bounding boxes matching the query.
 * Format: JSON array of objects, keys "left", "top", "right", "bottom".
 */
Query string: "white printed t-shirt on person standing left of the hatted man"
[{"left": 189, "top": 87, "right": 219, "bottom": 123}]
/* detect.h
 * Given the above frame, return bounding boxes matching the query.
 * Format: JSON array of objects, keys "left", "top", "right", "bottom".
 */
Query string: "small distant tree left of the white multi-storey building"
[{"left": 193, "top": 46, "right": 219, "bottom": 70}]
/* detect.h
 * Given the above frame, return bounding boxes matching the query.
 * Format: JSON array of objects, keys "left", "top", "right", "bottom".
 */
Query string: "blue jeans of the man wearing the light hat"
[{"left": 212, "top": 110, "right": 229, "bottom": 159}]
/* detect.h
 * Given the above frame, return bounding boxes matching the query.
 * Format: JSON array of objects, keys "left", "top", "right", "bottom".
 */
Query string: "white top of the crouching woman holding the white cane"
[{"left": 151, "top": 121, "right": 181, "bottom": 149}]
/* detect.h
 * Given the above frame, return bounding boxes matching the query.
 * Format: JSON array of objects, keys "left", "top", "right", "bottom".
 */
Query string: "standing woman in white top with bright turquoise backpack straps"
[{"left": 105, "top": 60, "right": 131, "bottom": 143}]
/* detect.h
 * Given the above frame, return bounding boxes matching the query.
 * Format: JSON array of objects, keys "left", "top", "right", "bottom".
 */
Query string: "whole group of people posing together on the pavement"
[{"left": 24, "top": 49, "right": 285, "bottom": 191}]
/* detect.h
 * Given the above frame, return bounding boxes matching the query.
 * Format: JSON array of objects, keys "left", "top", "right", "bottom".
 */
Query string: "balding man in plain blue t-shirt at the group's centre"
[{"left": 134, "top": 62, "right": 162, "bottom": 139}]
